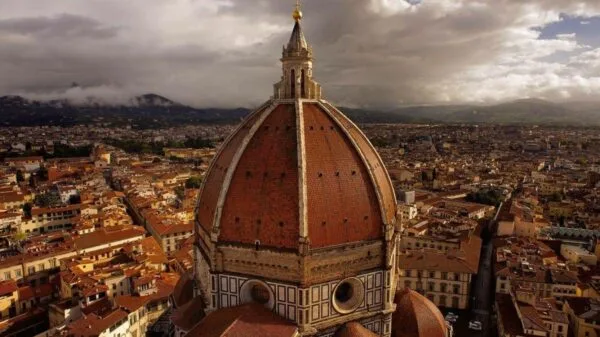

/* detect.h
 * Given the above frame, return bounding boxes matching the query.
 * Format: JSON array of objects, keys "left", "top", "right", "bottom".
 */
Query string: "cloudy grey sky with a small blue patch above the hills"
[{"left": 0, "top": 0, "right": 600, "bottom": 107}]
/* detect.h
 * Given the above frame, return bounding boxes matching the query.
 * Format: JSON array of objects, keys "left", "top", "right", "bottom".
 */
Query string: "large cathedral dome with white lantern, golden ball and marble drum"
[{"left": 194, "top": 1, "right": 399, "bottom": 337}]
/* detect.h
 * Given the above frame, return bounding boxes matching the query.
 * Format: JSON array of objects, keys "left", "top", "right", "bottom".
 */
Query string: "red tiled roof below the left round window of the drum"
[{"left": 186, "top": 303, "right": 297, "bottom": 337}]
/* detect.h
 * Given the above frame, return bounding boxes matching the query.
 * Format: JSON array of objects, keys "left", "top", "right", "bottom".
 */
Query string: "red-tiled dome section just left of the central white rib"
[{"left": 220, "top": 104, "right": 300, "bottom": 249}]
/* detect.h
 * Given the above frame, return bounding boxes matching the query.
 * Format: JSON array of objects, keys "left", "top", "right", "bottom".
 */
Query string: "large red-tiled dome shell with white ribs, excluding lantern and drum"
[{"left": 197, "top": 100, "right": 395, "bottom": 249}]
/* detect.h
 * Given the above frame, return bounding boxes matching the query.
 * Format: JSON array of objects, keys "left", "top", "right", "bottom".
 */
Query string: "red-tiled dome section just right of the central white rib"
[{"left": 303, "top": 103, "right": 382, "bottom": 248}]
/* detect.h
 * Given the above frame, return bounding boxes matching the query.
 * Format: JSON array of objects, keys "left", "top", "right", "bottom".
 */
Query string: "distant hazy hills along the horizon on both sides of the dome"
[{"left": 0, "top": 94, "right": 600, "bottom": 128}]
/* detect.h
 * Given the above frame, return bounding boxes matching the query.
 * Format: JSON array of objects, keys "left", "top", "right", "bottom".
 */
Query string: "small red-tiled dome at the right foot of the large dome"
[{"left": 392, "top": 288, "right": 448, "bottom": 337}]
